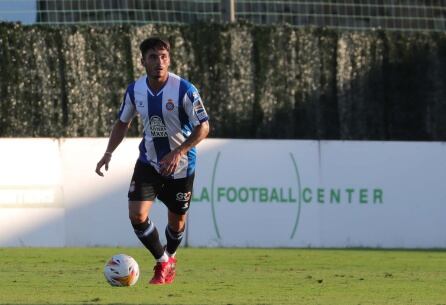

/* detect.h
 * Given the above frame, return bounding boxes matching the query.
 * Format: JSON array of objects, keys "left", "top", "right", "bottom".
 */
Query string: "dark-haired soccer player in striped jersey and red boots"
[{"left": 96, "top": 37, "right": 209, "bottom": 285}]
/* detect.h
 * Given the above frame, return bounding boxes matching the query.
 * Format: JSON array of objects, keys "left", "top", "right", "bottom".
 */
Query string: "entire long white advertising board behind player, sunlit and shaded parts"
[{"left": 0, "top": 138, "right": 446, "bottom": 248}]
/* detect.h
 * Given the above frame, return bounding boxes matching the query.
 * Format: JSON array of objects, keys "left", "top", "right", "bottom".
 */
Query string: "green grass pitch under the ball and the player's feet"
[{"left": 0, "top": 248, "right": 446, "bottom": 305}]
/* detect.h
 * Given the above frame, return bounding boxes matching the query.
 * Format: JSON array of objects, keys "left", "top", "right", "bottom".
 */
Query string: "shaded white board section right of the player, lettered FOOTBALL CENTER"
[{"left": 189, "top": 140, "right": 446, "bottom": 248}]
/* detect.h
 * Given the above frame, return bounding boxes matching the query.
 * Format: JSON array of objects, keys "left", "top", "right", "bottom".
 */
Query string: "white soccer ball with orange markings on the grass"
[{"left": 104, "top": 254, "right": 139, "bottom": 286}]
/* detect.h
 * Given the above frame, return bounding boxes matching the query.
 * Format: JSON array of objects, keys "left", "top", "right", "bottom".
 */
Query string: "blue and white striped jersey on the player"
[{"left": 119, "top": 73, "right": 208, "bottom": 179}]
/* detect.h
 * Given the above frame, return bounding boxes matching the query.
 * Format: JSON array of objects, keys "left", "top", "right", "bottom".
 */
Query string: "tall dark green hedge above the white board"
[{"left": 0, "top": 23, "right": 446, "bottom": 141}]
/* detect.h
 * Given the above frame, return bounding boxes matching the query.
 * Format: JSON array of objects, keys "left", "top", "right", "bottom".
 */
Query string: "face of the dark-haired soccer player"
[{"left": 141, "top": 49, "right": 170, "bottom": 81}]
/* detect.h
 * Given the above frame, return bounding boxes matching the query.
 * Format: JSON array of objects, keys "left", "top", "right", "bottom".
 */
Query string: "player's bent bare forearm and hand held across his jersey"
[{"left": 160, "top": 121, "right": 209, "bottom": 176}]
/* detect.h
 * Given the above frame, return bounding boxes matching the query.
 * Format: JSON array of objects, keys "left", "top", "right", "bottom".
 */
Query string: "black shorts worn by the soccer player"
[{"left": 128, "top": 160, "right": 195, "bottom": 215}]
